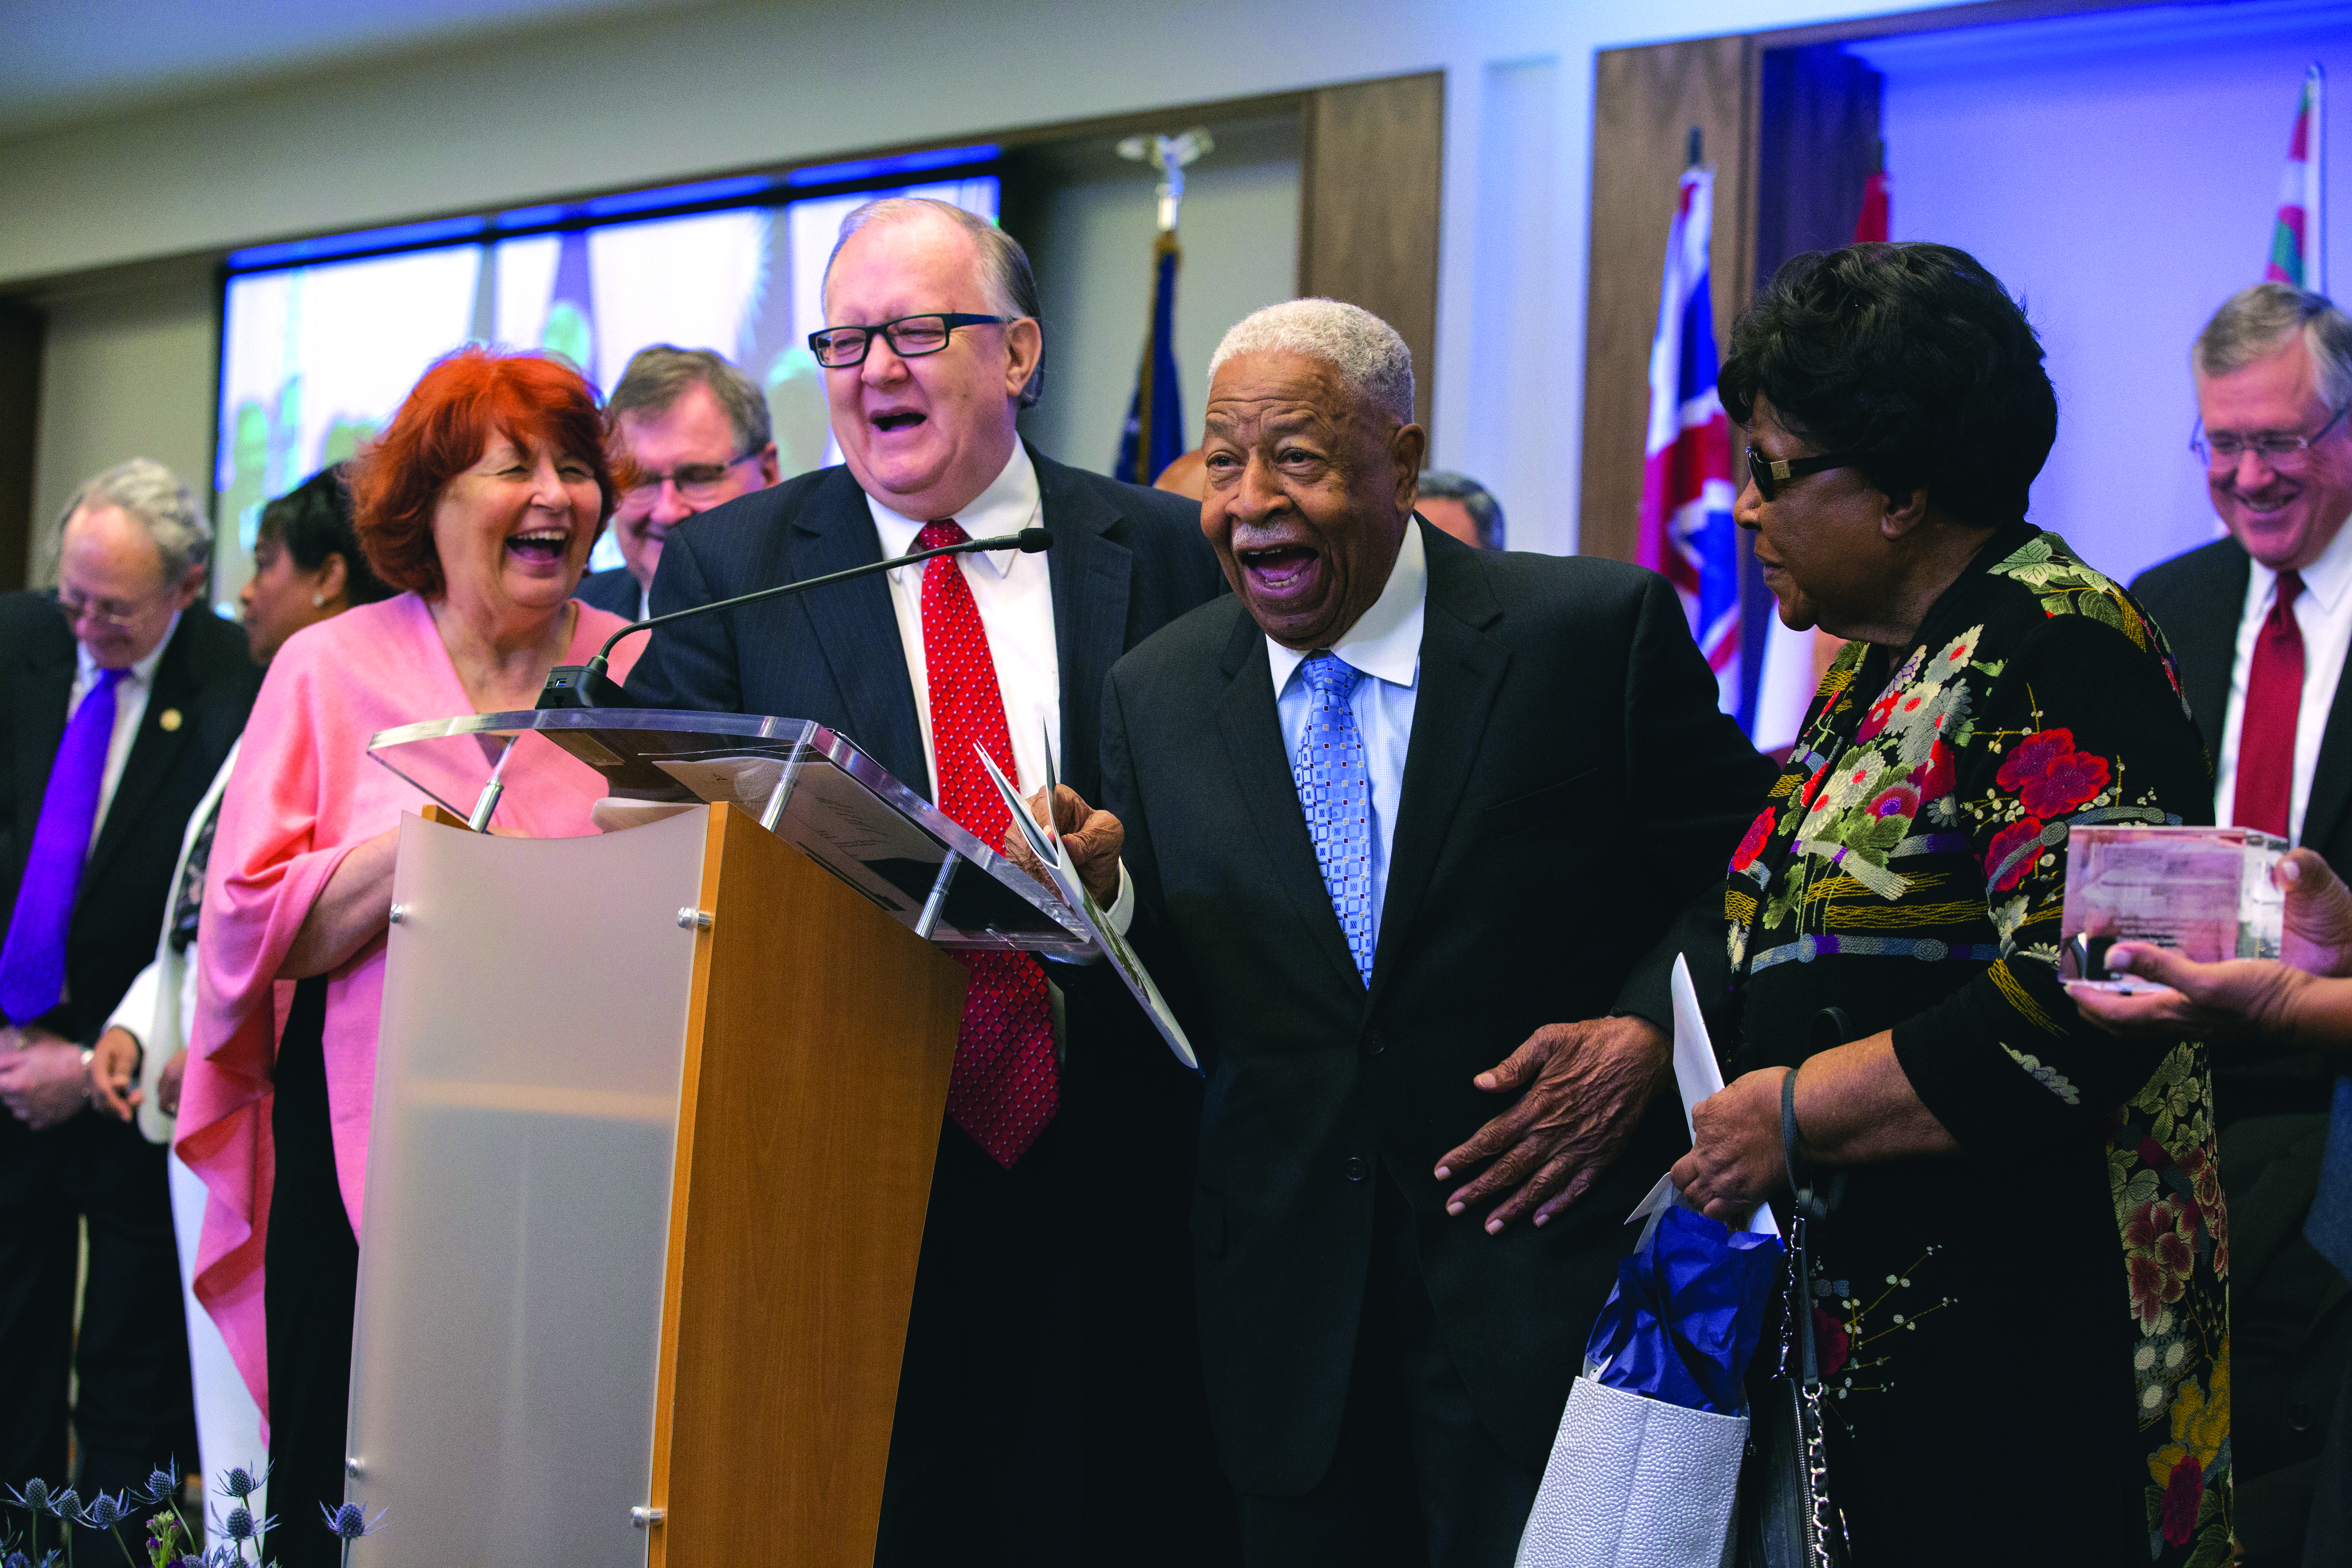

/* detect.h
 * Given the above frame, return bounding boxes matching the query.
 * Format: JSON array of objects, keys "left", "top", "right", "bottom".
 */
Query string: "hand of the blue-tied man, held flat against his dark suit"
[{"left": 1437, "top": 1018, "right": 1672, "bottom": 1236}]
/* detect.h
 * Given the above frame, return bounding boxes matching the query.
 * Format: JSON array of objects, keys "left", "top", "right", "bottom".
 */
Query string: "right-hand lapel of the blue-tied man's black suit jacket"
[{"left": 1373, "top": 533, "right": 1510, "bottom": 1002}]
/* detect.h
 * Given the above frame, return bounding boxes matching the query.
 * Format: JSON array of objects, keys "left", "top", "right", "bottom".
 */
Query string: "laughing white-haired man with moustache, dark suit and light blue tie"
[{"left": 1056, "top": 298, "right": 1771, "bottom": 1568}]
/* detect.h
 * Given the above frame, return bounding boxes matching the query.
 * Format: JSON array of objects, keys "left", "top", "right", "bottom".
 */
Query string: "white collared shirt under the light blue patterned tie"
[{"left": 1265, "top": 524, "right": 1430, "bottom": 943}]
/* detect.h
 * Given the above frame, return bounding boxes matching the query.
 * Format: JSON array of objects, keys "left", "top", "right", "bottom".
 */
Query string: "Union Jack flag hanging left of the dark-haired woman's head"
[{"left": 1642, "top": 167, "right": 1740, "bottom": 715}]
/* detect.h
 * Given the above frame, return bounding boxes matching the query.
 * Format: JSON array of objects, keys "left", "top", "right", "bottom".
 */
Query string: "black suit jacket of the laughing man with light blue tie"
[{"left": 1103, "top": 524, "right": 1773, "bottom": 1495}]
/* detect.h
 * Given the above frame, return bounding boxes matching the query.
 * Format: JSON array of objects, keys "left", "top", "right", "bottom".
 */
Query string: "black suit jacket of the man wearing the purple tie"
[{"left": 0, "top": 592, "right": 261, "bottom": 1044}]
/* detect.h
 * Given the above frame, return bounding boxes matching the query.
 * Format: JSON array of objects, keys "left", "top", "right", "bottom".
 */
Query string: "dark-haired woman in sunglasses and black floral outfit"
[{"left": 1675, "top": 245, "right": 2230, "bottom": 1563}]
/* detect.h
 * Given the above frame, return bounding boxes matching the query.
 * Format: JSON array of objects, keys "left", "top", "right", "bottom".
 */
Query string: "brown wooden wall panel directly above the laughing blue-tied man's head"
[{"left": 1298, "top": 71, "right": 1446, "bottom": 428}]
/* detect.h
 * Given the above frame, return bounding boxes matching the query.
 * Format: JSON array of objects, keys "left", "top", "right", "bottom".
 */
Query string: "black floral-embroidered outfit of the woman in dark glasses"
[{"left": 1724, "top": 524, "right": 2230, "bottom": 1568}]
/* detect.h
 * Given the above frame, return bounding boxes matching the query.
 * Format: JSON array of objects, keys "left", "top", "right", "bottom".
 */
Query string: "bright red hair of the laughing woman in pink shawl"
[{"left": 350, "top": 345, "right": 621, "bottom": 599}]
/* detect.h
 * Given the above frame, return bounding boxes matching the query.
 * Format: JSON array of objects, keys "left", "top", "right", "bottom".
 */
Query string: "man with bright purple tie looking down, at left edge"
[{"left": 0, "top": 459, "right": 261, "bottom": 1556}]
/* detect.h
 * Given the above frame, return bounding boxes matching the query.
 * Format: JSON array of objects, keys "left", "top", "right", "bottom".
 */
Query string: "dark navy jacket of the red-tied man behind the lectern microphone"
[{"left": 628, "top": 449, "right": 1225, "bottom": 799}]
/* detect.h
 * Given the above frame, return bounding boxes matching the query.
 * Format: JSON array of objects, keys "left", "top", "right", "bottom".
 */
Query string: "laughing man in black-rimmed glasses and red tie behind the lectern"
[{"left": 628, "top": 198, "right": 1235, "bottom": 1568}]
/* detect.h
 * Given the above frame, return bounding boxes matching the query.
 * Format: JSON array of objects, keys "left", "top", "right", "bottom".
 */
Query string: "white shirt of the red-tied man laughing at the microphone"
[{"left": 866, "top": 442, "right": 1061, "bottom": 799}]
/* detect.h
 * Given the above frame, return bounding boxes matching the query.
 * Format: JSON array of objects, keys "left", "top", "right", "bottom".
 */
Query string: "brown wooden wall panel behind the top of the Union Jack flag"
[{"left": 1576, "top": 38, "right": 1757, "bottom": 562}]
